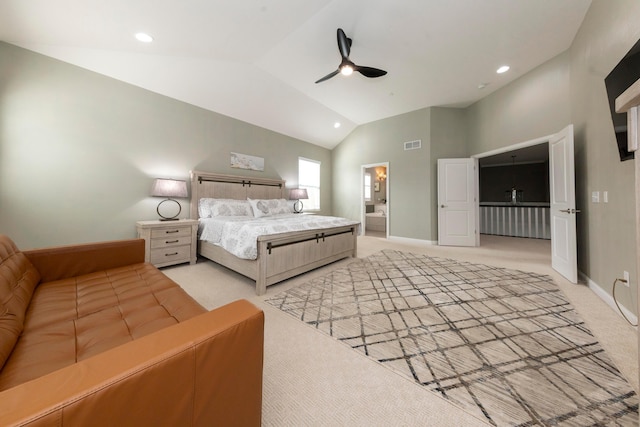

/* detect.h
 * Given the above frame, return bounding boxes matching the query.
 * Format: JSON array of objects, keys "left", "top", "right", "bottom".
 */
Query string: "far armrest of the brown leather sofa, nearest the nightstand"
[{"left": 22, "top": 239, "right": 144, "bottom": 282}]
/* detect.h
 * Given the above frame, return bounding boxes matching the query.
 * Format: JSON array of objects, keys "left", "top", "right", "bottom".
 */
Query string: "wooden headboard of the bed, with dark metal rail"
[{"left": 190, "top": 171, "right": 286, "bottom": 219}]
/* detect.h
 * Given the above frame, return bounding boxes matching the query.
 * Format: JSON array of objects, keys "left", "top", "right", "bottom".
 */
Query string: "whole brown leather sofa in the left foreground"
[{"left": 0, "top": 235, "right": 264, "bottom": 426}]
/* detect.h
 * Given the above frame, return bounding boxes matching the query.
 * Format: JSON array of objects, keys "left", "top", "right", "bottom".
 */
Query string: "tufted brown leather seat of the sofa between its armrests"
[{"left": 0, "top": 264, "right": 206, "bottom": 390}]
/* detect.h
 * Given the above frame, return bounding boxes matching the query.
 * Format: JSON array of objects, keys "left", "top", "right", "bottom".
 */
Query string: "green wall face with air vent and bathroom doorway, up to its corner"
[{"left": 332, "top": 109, "right": 432, "bottom": 240}]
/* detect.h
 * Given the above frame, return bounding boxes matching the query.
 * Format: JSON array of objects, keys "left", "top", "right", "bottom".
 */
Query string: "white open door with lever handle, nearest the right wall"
[{"left": 549, "top": 125, "right": 579, "bottom": 283}]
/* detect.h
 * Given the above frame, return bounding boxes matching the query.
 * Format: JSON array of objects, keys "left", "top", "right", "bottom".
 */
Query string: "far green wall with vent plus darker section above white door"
[{"left": 333, "top": 107, "right": 468, "bottom": 243}]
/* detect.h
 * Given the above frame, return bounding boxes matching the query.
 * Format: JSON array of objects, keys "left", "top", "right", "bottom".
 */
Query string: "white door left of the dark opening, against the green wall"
[{"left": 438, "top": 159, "right": 480, "bottom": 246}]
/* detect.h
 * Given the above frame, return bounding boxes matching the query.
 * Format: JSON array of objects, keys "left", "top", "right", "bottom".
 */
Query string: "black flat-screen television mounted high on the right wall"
[{"left": 604, "top": 40, "right": 640, "bottom": 161}]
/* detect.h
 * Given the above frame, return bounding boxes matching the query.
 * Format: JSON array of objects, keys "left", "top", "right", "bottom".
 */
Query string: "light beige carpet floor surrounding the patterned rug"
[{"left": 163, "top": 236, "right": 638, "bottom": 426}]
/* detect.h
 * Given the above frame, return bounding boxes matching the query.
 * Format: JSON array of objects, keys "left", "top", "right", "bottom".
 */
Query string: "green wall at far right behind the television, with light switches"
[{"left": 570, "top": 0, "right": 640, "bottom": 313}]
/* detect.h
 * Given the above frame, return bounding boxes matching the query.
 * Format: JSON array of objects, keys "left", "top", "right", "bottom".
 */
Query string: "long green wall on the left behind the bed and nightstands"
[{"left": 0, "top": 43, "right": 332, "bottom": 249}]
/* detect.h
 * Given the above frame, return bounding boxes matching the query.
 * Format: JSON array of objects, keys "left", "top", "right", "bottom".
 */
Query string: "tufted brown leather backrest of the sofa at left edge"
[{"left": 0, "top": 234, "right": 40, "bottom": 369}]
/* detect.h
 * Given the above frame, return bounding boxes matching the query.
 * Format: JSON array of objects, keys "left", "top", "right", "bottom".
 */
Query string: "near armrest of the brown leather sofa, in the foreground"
[{"left": 0, "top": 300, "right": 264, "bottom": 426}]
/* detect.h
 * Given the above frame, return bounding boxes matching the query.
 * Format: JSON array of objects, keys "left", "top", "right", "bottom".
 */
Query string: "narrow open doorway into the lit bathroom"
[{"left": 361, "top": 162, "right": 391, "bottom": 239}]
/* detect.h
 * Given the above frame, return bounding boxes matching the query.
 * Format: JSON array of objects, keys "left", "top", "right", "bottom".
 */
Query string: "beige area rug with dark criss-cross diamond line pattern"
[{"left": 267, "top": 250, "right": 638, "bottom": 426}]
